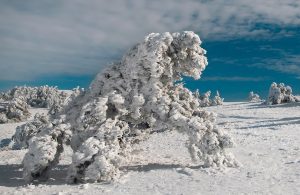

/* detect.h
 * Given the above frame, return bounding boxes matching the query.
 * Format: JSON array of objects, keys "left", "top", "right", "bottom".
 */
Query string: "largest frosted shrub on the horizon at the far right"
[{"left": 267, "top": 82, "right": 300, "bottom": 104}]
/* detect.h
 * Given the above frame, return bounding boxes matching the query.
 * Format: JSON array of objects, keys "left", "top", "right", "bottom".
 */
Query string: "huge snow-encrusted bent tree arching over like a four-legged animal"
[{"left": 23, "top": 31, "right": 237, "bottom": 182}]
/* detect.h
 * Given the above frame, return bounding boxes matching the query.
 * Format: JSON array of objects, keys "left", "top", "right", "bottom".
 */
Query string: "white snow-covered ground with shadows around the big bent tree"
[{"left": 0, "top": 102, "right": 300, "bottom": 195}]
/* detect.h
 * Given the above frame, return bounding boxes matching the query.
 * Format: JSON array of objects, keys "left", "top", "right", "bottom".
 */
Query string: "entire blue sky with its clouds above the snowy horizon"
[{"left": 0, "top": 0, "right": 300, "bottom": 101}]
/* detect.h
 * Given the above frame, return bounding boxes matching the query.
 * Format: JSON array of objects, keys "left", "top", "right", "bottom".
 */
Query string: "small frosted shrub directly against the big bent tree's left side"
[{"left": 12, "top": 114, "right": 49, "bottom": 149}]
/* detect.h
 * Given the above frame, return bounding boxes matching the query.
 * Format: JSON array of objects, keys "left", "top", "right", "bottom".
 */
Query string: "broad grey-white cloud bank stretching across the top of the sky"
[{"left": 0, "top": 0, "right": 300, "bottom": 80}]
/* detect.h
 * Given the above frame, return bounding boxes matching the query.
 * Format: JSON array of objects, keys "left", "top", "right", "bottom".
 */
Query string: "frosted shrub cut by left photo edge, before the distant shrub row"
[{"left": 0, "top": 97, "right": 30, "bottom": 123}]
